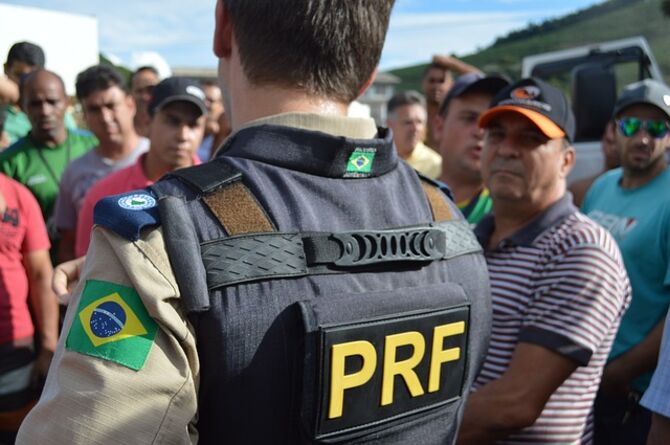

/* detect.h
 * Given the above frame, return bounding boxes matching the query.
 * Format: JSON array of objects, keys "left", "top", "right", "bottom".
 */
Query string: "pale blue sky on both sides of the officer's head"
[{"left": 0, "top": 0, "right": 599, "bottom": 70}]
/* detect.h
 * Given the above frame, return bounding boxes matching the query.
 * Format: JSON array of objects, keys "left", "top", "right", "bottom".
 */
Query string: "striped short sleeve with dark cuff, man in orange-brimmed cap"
[{"left": 519, "top": 240, "right": 630, "bottom": 366}]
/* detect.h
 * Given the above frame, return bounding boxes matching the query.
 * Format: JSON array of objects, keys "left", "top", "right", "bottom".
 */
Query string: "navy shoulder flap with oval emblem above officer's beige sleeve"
[{"left": 93, "top": 189, "right": 160, "bottom": 241}]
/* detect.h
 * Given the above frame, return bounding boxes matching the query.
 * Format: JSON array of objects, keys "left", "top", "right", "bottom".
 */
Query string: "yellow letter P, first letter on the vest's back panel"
[{"left": 328, "top": 340, "right": 377, "bottom": 419}]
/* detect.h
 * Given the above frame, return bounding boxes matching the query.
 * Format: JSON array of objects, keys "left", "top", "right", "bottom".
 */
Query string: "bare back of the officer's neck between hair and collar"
[{"left": 231, "top": 86, "right": 347, "bottom": 131}]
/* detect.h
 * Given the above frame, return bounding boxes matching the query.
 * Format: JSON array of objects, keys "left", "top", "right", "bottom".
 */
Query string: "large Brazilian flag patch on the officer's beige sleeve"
[{"left": 65, "top": 280, "right": 158, "bottom": 371}]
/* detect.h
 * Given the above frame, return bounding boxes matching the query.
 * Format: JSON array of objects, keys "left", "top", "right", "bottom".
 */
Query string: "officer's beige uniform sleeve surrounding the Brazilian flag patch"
[{"left": 17, "top": 227, "right": 199, "bottom": 445}]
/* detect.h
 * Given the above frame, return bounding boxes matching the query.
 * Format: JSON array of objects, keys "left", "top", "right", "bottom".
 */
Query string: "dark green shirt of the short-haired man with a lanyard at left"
[{"left": 0, "top": 130, "right": 98, "bottom": 222}]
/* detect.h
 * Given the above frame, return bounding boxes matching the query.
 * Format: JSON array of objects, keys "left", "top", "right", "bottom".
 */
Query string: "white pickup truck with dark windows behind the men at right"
[{"left": 522, "top": 37, "right": 663, "bottom": 182}]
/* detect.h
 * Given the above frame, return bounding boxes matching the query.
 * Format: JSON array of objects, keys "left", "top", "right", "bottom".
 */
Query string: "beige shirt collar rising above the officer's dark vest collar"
[{"left": 239, "top": 113, "right": 377, "bottom": 139}]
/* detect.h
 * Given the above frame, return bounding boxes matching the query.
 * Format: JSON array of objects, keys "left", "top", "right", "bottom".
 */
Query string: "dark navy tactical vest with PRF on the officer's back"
[{"left": 152, "top": 125, "right": 490, "bottom": 444}]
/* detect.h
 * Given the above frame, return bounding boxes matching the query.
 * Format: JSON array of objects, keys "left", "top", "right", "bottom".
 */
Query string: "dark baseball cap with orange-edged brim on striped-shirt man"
[{"left": 479, "top": 78, "right": 575, "bottom": 141}]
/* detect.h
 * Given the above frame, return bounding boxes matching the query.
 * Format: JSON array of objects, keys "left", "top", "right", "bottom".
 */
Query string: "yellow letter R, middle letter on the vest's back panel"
[{"left": 381, "top": 332, "right": 426, "bottom": 406}]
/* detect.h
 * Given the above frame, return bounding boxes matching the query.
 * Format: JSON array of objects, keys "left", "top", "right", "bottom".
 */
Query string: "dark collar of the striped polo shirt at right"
[{"left": 475, "top": 192, "right": 577, "bottom": 249}]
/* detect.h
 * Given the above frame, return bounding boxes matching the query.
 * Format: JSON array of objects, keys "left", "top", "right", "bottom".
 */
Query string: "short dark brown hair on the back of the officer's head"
[{"left": 224, "top": 0, "right": 394, "bottom": 103}]
